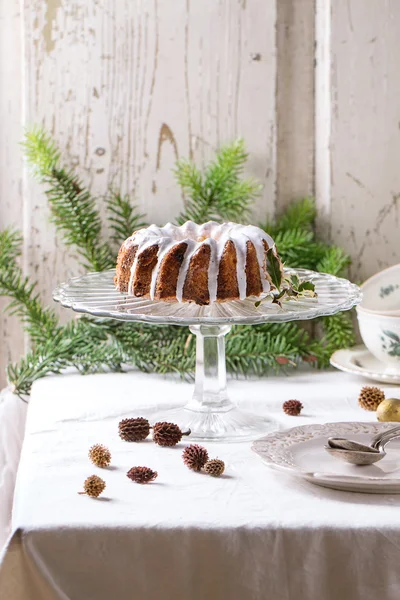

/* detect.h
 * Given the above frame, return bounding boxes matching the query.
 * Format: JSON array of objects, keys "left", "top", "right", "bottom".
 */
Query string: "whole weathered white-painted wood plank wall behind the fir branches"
[{"left": 0, "top": 0, "right": 400, "bottom": 384}]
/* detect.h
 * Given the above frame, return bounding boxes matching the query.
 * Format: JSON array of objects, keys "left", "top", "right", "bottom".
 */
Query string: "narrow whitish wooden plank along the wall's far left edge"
[{"left": 0, "top": 0, "right": 24, "bottom": 389}]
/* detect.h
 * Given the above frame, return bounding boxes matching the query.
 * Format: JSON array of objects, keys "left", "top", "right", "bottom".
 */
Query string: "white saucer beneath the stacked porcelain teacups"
[{"left": 330, "top": 346, "right": 400, "bottom": 384}]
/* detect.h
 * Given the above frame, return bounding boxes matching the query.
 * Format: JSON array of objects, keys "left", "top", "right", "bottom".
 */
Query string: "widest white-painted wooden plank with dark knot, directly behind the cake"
[{"left": 24, "top": 0, "right": 276, "bottom": 318}]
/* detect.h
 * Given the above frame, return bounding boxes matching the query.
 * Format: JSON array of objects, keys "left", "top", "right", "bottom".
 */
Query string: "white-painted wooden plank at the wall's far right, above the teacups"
[{"left": 323, "top": 0, "right": 400, "bottom": 280}]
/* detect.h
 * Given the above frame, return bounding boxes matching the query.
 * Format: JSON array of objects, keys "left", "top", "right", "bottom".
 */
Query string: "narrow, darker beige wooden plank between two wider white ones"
[{"left": 276, "top": 0, "right": 315, "bottom": 212}]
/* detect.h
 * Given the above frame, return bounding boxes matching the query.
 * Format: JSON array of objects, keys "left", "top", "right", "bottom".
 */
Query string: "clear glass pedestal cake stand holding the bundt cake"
[{"left": 53, "top": 269, "right": 362, "bottom": 442}]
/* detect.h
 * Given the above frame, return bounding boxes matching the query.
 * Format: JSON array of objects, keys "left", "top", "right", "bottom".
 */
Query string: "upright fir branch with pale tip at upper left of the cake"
[{"left": 23, "top": 129, "right": 115, "bottom": 271}]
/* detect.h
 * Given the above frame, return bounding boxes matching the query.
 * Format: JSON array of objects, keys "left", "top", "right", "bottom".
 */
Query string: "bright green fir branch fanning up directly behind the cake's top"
[{"left": 175, "top": 139, "right": 261, "bottom": 224}]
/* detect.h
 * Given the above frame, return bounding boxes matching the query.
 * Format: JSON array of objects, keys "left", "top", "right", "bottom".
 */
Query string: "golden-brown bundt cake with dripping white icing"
[{"left": 115, "top": 221, "right": 282, "bottom": 305}]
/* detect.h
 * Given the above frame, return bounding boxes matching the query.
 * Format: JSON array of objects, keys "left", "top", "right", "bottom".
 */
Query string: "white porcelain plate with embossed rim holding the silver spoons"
[{"left": 252, "top": 422, "right": 400, "bottom": 494}]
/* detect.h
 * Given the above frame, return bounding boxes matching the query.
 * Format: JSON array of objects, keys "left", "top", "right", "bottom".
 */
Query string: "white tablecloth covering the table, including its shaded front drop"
[{"left": 0, "top": 371, "right": 400, "bottom": 600}]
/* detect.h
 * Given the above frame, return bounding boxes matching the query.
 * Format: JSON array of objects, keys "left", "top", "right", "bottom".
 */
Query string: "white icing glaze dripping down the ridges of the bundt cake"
[{"left": 124, "top": 221, "right": 275, "bottom": 303}]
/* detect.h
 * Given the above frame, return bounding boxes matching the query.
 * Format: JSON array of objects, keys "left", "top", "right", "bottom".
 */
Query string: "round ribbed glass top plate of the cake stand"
[{"left": 53, "top": 269, "right": 362, "bottom": 325}]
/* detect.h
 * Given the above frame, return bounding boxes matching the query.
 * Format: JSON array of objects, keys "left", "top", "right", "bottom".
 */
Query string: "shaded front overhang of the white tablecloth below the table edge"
[{"left": 0, "top": 527, "right": 400, "bottom": 600}]
